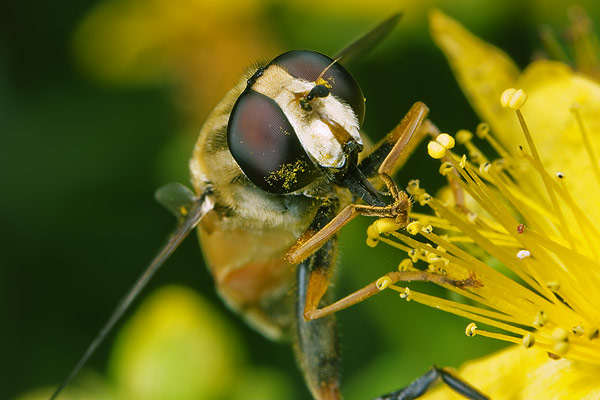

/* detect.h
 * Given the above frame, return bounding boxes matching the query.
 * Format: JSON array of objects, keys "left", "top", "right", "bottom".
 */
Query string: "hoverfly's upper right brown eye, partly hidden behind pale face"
[{"left": 271, "top": 50, "right": 365, "bottom": 126}]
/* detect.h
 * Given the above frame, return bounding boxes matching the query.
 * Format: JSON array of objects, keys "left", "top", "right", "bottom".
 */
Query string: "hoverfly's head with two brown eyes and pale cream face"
[{"left": 228, "top": 50, "right": 365, "bottom": 194}]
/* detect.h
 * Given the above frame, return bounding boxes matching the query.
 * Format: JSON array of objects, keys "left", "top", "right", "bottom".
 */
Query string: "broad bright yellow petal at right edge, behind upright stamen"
[{"left": 513, "top": 61, "right": 600, "bottom": 225}]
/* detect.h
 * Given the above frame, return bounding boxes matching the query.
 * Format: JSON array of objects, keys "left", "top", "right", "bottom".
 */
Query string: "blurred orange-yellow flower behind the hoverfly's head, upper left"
[{"left": 74, "top": 0, "right": 279, "bottom": 126}]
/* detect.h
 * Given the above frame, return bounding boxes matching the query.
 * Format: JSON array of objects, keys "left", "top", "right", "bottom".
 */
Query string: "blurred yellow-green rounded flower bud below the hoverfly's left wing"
[{"left": 110, "top": 286, "right": 244, "bottom": 400}]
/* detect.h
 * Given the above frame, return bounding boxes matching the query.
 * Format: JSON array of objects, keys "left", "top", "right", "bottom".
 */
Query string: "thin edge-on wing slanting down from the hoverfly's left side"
[{"left": 50, "top": 183, "right": 214, "bottom": 400}]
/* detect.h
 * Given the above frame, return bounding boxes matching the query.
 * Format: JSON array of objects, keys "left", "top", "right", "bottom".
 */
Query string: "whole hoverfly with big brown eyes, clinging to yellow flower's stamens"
[{"left": 51, "top": 14, "right": 487, "bottom": 400}]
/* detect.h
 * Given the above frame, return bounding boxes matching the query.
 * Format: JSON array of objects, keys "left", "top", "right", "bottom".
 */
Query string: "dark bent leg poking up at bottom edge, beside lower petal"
[{"left": 374, "top": 365, "right": 489, "bottom": 400}]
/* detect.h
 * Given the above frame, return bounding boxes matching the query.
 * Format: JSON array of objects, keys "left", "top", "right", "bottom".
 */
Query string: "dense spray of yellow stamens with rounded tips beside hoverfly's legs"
[{"left": 368, "top": 89, "right": 600, "bottom": 364}]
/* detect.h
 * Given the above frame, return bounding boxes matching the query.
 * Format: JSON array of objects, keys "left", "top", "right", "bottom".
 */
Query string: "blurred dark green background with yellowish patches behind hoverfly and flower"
[{"left": 0, "top": 0, "right": 600, "bottom": 400}]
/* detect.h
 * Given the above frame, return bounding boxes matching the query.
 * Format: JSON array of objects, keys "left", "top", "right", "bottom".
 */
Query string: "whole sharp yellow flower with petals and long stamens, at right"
[{"left": 367, "top": 12, "right": 600, "bottom": 399}]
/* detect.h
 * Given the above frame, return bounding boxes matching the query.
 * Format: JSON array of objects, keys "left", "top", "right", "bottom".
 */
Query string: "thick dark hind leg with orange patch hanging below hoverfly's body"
[{"left": 294, "top": 225, "right": 341, "bottom": 400}]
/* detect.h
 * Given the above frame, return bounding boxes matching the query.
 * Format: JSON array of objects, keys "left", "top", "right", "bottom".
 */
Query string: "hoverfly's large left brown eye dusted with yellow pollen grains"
[{"left": 227, "top": 90, "right": 320, "bottom": 194}]
